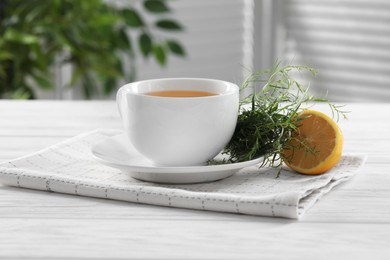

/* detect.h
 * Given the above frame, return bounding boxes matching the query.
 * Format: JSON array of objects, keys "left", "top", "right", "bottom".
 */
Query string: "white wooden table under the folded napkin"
[{"left": 0, "top": 100, "right": 390, "bottom": 259}]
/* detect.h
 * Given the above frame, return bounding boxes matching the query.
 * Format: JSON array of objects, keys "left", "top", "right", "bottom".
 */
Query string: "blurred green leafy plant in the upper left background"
[{"left": 0, "top": 0, "right": 185, "bottom": 99}]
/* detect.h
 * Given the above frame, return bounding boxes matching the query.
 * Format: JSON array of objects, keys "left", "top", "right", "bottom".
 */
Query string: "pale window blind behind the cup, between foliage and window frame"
[{"left": 137, "top": 0, "right": 253, "bottom": 83}]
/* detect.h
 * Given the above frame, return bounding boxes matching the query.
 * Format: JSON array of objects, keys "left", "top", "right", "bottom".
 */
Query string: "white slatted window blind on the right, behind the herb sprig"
[{"left": 279, "top": 0, "right": 390, "bottom": 102}]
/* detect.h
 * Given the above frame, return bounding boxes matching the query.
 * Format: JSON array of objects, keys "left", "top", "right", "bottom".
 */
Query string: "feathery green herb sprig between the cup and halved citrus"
[{"left": 219, "top": 62, "right": 346, "bottom": 167}]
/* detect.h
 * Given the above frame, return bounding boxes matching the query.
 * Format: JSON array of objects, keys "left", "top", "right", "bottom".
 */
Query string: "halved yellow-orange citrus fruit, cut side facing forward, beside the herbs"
[{"left": 283, "top": 110, "right": 343, "bottom": 174}]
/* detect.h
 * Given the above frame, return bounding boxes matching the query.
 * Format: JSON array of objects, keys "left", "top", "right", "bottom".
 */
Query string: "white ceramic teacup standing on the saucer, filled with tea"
[{"left": 117, "top": 78, "right": 239, "bottom": 166}]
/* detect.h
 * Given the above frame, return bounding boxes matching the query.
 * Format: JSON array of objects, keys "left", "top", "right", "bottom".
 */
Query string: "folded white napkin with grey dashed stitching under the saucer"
[{"left": 0, "top": 130, "right": 365, "bottom": 218}]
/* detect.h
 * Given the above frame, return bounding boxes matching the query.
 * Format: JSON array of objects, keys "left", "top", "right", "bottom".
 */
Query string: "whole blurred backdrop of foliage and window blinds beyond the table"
[{"left": 0, "top": 0, "right": 390, "bottom": 102}]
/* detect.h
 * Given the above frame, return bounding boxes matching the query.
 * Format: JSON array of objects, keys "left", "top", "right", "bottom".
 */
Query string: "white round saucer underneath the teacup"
[{"left": 92, "top": 134, "right": 263, "bottom": 184}]
